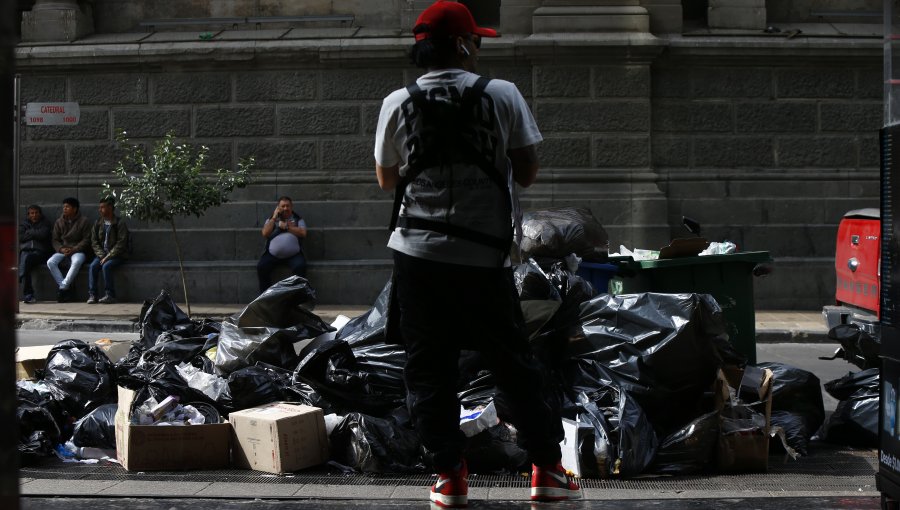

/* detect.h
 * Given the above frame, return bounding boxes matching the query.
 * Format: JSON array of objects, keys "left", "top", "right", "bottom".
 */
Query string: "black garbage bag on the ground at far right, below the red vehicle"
[{"left": 814, "top": 368, "right": 881, "bottom": 448}]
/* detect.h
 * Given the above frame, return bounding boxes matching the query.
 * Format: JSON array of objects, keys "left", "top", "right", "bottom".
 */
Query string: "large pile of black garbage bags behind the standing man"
[{"left": 18, "top": 209, "right": 840, "bottom": 477}]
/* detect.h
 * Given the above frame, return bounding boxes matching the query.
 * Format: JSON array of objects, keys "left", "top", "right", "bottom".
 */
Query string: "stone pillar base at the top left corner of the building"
[{"left": 22, "top": 0, "right": 94, "bottom": 42}]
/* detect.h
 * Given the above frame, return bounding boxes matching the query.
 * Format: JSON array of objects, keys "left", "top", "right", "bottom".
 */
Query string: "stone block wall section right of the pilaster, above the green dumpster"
[{"left": 653, "top": 50, "right": 882, "bottom": 309}]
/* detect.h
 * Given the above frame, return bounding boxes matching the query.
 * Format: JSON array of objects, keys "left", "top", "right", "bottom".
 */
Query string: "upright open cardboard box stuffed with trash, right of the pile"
[{"left": 716, "top": 366, "right": 773, "bottom": 472}]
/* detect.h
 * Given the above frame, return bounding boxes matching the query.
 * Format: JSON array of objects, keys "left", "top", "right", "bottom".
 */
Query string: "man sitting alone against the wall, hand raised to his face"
[{"left": 256, "top": 197, "right": 306, "bottom": 294}]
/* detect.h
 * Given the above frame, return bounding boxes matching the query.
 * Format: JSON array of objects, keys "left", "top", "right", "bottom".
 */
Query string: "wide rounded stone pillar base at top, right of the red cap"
[{"left": 531, "top": 0, "right": 650, "bottom": 34}]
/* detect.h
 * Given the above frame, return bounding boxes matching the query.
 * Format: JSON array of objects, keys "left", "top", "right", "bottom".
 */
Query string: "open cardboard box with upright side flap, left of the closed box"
[{"left": 116, "top": 386, "right": 231, "bottom": 471}]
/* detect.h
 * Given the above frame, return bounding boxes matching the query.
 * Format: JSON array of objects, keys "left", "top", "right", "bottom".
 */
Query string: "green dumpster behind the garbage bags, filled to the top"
[{"left": 609, "top": 251, "right": 772, "bottom": 363}]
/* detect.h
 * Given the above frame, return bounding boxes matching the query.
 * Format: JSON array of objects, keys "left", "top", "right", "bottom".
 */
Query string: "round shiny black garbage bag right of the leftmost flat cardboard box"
[{"left": 38, "top": 339, "right": 118, "bottom": 419}]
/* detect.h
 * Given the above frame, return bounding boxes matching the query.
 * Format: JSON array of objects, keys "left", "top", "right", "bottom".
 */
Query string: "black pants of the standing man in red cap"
[{"left": 394, "top": 252, "right": 563, "bottom": 471}]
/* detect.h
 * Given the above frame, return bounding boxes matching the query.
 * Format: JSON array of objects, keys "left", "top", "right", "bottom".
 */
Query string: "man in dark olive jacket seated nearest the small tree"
[{"left": 87, "top": 197, "right": 128, "bottom": 305}]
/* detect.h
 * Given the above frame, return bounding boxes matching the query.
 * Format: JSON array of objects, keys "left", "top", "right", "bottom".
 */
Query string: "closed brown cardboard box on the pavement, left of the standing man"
[{"left": 228, "top": 402, "right": 330, "bottom": 473}]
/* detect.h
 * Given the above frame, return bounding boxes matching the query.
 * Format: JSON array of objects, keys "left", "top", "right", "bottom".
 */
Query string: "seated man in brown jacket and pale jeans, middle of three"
[{"left": 47, "top": 197, "right": 91, "bottom": 303}]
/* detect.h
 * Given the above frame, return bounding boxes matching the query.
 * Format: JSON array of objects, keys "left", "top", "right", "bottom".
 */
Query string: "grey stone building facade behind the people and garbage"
[{"left": 16, "top": 0, "right": 882, "bottom": 309}]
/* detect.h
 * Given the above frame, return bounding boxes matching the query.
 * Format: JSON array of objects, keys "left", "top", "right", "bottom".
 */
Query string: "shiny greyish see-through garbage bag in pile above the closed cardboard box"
[{"left": 215, "top": 322, "right": 310, "bottom": 376}]
